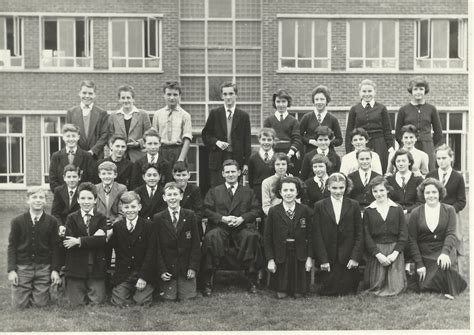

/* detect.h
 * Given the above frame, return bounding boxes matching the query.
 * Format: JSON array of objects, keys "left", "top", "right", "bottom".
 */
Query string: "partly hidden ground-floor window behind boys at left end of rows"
[{"left": 41, "top": 116, "right": 66, "bottom": 184}]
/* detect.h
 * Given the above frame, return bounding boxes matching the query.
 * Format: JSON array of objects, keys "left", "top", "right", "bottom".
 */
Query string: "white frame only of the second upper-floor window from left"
[{"left": 39, "top": 16, "right": 94, "bottom": 70}]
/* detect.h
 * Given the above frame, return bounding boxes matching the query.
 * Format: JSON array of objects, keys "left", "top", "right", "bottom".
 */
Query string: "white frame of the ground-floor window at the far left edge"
[{"left": 0, "top": 114, "right": 27, "bottom": 189}]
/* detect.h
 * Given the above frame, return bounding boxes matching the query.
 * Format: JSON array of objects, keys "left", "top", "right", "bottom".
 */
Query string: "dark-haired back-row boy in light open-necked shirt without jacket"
[{"left": 152, "top": 81, "right": 193, "bottom": 166}]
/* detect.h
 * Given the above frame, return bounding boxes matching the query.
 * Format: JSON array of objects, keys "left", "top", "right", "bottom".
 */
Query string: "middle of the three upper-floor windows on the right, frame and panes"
[{"left": 347, "top": 20, "right": 398, "bottom": 70}]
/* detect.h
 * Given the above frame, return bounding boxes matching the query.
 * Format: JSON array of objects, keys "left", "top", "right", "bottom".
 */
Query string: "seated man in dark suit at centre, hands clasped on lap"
[{"left": 202, "top": 159, "right": 264, "bottom": 296}]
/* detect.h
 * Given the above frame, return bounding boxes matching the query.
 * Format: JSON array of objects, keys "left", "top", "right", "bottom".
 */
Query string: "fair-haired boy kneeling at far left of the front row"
[{"left": 7, "top": 186, "right": 61, "bottom": 308}]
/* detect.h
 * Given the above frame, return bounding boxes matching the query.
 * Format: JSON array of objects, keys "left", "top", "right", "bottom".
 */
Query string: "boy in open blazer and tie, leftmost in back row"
[{"left": 66, "top": 80, "right": 109, "bottom": 160}]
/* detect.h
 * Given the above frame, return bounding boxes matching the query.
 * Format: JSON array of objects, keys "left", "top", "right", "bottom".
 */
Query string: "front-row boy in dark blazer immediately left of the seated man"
[{"left": 153, "top": 182, "right": 201, "bottom": 300}]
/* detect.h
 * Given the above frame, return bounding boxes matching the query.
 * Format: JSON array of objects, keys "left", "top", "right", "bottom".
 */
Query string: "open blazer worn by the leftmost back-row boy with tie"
[{"left": 66, "top": 104, "right": 109, "bottom": 158}]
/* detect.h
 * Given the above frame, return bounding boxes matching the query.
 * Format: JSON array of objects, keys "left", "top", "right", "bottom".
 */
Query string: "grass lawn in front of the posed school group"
[{"left": 0, "top": 209, "right": 470, "bottom": 332}]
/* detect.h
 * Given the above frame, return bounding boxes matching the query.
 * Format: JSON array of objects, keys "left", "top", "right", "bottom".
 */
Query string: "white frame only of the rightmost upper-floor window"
[{"left": 414, "top": 18, "right": 468, "bottom": 72}]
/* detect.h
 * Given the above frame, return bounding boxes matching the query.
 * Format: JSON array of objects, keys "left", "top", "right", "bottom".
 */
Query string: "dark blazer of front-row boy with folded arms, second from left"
[{"left": 65, "top": 210, "right": 107, "bottom": 279}]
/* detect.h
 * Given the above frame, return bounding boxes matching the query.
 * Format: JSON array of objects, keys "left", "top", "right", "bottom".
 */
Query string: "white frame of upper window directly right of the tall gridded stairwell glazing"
[{"left": 278, "top": 17, "right": 332, "bottom": 73}]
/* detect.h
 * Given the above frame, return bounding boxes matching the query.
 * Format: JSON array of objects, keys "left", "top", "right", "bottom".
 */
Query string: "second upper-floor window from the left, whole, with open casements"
[{"left": 41, "top": 18, "right": 92, "bottom": 68}]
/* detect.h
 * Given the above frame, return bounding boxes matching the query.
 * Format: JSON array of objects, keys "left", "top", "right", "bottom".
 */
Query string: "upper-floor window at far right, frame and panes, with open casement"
[{"left": 415, "top": 19, "right": 467, "bottom": 69}]
